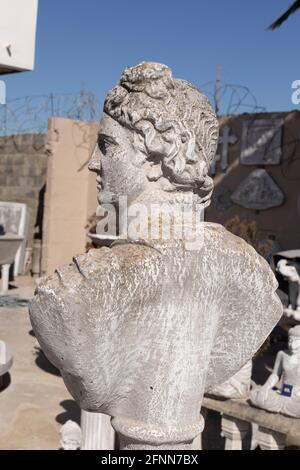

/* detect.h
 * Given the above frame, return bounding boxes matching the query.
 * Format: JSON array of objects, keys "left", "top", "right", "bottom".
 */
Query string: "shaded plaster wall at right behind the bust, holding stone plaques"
[{"left": 205, "top": 111, "right": 300, "bottom": 250}]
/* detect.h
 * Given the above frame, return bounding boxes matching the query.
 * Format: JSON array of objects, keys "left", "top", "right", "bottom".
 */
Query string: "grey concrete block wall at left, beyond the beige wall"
[{"left": 0, "top": 133, "right": 47, "bottom": 247}]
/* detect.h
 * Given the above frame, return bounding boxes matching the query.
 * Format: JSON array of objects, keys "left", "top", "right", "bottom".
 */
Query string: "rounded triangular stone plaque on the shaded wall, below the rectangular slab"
[{"left": 231, "top": 168, "right": 284, "bottom": 210}]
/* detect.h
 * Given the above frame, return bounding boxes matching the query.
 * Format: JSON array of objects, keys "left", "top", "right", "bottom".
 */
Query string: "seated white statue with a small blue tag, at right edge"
[{"left": 251, "top": 325, "right": 300, "bottom": 418}]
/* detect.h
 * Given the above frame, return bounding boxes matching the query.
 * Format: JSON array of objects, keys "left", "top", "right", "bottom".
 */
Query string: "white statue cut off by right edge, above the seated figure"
[{"left": 276, "top": 259, "right": 300, "bottom": 321}]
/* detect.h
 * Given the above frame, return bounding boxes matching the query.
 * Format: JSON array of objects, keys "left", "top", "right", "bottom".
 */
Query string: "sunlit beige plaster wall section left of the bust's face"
[{"left": 42, "top": 118, "right": 98, "bottom": 274}]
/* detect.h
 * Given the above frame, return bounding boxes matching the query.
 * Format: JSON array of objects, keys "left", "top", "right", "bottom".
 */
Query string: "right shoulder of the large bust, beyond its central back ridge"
[{"left": 202, "top": 223, "right": 282, "bottom": 390}]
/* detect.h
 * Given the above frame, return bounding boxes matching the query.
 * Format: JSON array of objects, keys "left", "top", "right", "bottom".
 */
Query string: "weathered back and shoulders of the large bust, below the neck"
[{"left": 31, "top": 224, "right": 282, "bottom": 444}]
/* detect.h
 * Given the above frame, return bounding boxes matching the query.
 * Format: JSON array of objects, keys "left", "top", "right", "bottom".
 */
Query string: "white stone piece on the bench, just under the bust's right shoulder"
[{"left": 211, "top": 359, "right": 252, "bottom": 398}]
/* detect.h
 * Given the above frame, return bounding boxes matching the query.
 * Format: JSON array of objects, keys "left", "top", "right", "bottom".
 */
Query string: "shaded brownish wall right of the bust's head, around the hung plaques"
[{"left": 205, "top": 111, "right": 300, "bottom": 254}]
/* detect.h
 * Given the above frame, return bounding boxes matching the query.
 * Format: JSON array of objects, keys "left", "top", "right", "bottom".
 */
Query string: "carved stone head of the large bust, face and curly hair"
[{"left": 89, "top": 62, "right": 218, "bottom": 207}]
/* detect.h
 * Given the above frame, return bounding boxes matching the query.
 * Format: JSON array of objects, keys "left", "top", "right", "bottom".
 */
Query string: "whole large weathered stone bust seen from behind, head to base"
[{"left": 30, "top": 62, "right": 282, "bottom": 449}]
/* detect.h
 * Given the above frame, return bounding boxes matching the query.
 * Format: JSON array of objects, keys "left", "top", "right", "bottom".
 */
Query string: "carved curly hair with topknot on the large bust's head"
[{"left": 104, "top": 62, "right": 219, "bottom": 200}]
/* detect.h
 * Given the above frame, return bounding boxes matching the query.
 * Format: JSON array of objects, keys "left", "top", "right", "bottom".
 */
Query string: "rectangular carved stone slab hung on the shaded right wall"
[{"left": 240, "top": 119, "right": 283, "bottom": 165}]
